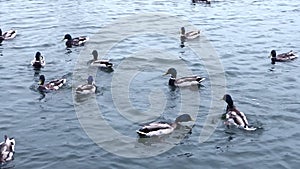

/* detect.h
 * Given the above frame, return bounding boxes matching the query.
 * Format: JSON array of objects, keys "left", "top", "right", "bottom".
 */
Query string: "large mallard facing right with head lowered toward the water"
[{"left": 136, "top": 114, "right": 194, "bottom": 137}]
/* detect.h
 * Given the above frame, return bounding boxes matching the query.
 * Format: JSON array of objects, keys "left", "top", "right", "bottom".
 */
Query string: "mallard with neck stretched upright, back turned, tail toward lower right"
[{"left": 222, "top": 94, "right": 256, "bottom": 131}]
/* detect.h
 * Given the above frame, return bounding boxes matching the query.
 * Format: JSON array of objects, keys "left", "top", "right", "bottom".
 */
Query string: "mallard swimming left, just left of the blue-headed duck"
[{"left": 38, "top": 75, "right": 67, "bottom": 91}]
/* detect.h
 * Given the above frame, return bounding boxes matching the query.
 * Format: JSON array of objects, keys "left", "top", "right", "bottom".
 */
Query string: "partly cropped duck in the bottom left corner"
[{"left": 0, "top": 135, "right": 16, "bottom": 163}]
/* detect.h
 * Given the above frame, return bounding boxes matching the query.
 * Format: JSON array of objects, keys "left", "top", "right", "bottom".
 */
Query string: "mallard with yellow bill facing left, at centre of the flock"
[{"left": 164, "top": 68, "right": 205, "bottom": 87}]
